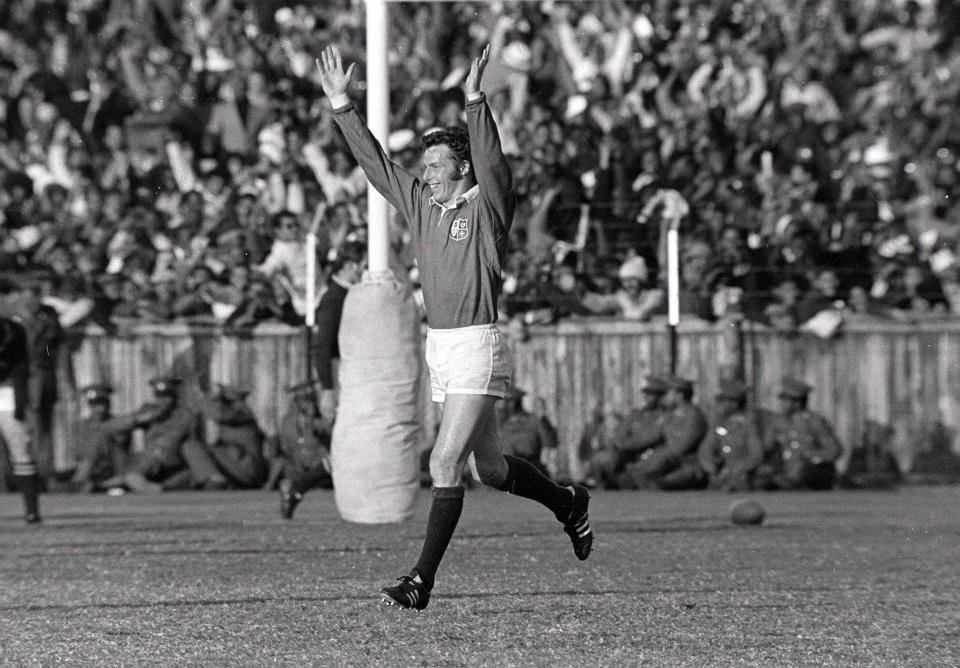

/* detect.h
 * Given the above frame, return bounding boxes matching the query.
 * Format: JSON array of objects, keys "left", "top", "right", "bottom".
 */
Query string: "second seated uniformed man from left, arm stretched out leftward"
[{"left": 104, "top": 376, "right": 228, "bottom": 492}]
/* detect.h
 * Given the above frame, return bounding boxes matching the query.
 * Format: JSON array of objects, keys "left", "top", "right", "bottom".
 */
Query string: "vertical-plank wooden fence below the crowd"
[{"left": 47, "top": 319, "right": 960, "bottom": 477}]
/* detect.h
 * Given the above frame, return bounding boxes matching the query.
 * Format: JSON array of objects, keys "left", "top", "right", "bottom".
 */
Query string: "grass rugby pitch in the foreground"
[{"left": 0, "top": 487, "right": 960, "bottom": 667}]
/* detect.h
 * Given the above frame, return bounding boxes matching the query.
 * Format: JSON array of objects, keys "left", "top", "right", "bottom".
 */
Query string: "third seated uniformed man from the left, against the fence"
[{"left": 200, "top": 383, "right": 267, "bottom": 489}]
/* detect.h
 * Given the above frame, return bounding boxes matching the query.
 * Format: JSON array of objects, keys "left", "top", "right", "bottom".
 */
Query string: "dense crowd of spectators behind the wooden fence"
[{"left": 0, "top": 0, "right": 960, "bottom": 340}]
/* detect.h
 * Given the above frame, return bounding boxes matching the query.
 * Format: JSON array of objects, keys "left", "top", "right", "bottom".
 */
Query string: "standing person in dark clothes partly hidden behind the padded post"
[{"left": 313, "top": 242, "right": 364, "bottom": 418}]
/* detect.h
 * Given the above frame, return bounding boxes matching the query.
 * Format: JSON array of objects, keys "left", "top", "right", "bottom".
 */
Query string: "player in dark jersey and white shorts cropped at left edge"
[{"left": 0, "top": 280, "right": 40, "bottom": 524}]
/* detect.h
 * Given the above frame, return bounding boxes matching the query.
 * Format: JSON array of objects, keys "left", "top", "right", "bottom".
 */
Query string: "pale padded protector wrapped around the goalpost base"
[{"left": 330, "top": 274, "right": 421, "bottom": 524}]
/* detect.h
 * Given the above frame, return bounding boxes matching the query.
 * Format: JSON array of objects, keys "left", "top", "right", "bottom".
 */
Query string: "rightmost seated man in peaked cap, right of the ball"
[{"left": 754, "top": 378, "right": 843, "bottom": 490}]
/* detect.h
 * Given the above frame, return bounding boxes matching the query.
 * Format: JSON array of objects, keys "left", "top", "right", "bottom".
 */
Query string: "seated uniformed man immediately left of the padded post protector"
[{"left": 277, "top": 382, "right": 333, "bottom": 519}]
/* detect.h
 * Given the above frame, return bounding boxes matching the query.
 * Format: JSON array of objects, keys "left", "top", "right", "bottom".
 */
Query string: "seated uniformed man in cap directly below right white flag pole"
[{"left": 625, "top": 374, "right": 707, "bottom": 490}]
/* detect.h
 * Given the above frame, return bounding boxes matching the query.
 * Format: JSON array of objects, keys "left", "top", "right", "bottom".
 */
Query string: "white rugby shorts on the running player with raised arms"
[{"left": 426, "top": 323, "right": 513, "bottom": 403}]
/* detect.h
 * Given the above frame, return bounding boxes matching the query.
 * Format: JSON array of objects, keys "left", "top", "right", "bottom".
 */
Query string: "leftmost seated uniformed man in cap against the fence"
[{"left": 70, "top": 385, "right": 130, "bottom": 492}]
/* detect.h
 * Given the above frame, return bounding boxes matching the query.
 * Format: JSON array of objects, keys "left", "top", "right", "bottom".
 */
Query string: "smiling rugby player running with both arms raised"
[{"left": 317, "top": 46, "right": 593, "bottom": 610}]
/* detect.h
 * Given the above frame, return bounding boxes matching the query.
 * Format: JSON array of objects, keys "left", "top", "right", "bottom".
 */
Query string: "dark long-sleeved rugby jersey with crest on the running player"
[{"left": 334, "top": 95, "right": 515, "bottom": 329}]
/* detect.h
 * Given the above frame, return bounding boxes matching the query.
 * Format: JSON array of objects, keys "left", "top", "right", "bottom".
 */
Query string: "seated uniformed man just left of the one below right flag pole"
[{"left": 590, "top": 376, "right": 667, "bottom": 489}]
